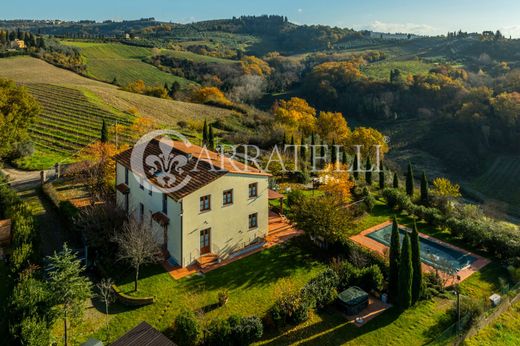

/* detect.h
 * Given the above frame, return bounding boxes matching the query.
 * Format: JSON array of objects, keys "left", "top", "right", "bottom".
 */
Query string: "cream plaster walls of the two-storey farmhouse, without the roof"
[{"left": 116, "top": 163, "right": 269, "bottom": 267}]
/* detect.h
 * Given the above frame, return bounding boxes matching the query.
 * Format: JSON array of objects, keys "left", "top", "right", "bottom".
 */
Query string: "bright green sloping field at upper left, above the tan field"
[{"left": 63, "top": 41, "right": 189, "bottom": 86}]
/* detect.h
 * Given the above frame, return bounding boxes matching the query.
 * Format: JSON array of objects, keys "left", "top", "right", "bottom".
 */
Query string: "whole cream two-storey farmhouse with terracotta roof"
[{"left": 116, "top": 139, "right": 270, "bottom": 267}]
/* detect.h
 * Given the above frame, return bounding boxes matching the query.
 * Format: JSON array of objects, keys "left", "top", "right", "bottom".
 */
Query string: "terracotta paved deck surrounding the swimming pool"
[{"left": 350, "top": 221, "right": 491, "bottom": 286}]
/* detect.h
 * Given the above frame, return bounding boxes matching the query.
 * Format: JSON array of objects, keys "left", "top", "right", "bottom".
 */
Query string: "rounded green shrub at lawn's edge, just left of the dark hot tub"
[{"left": 301, "top": 269, "right": 339, "bottom": 309}]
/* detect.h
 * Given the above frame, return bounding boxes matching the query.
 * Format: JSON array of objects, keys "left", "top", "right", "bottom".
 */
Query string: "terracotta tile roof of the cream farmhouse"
[{"left": 115, "top": 139, "right": 269, "bottom": 200}]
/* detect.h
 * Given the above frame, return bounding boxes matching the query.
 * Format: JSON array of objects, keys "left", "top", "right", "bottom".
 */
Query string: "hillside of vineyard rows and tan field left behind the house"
[{"left": 0, "top": 57, "right": 236, "bottom": 169}]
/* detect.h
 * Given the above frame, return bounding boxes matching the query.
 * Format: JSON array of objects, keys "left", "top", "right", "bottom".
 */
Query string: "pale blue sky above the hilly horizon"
[{"left": 0, "top": 0, "right": 520, "bottom": 37}]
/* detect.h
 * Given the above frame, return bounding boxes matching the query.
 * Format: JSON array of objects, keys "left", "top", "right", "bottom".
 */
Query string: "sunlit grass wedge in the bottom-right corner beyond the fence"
[{"left": 464, "top": 301, "right": 520, "bottom": 346}]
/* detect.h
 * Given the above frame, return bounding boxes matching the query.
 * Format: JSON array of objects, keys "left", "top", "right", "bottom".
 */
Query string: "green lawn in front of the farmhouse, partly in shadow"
[{"left": 63, "top": 239, "right": 325, "bottom": 343}]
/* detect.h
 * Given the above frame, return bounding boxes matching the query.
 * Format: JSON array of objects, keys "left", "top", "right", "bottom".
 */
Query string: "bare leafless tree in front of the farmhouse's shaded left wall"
[{"left": 114, "top": 217, "right": 161, "bottom": 291}]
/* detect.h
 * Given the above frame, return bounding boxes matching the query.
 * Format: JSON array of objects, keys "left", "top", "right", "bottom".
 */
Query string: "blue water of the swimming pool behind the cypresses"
[{"left": 367, "top": 225, "right": 476, "bottom": 271}]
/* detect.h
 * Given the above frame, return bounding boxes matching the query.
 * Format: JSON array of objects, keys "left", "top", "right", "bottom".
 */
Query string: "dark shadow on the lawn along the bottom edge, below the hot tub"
[{"left": 266, "top": 306, "right": 401, "bottom": 345}]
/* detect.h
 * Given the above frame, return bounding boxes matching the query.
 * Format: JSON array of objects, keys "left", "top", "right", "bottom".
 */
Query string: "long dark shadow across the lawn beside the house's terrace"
[{"left": 182, "top": 239, "right": 319, "bottom": 290}]
